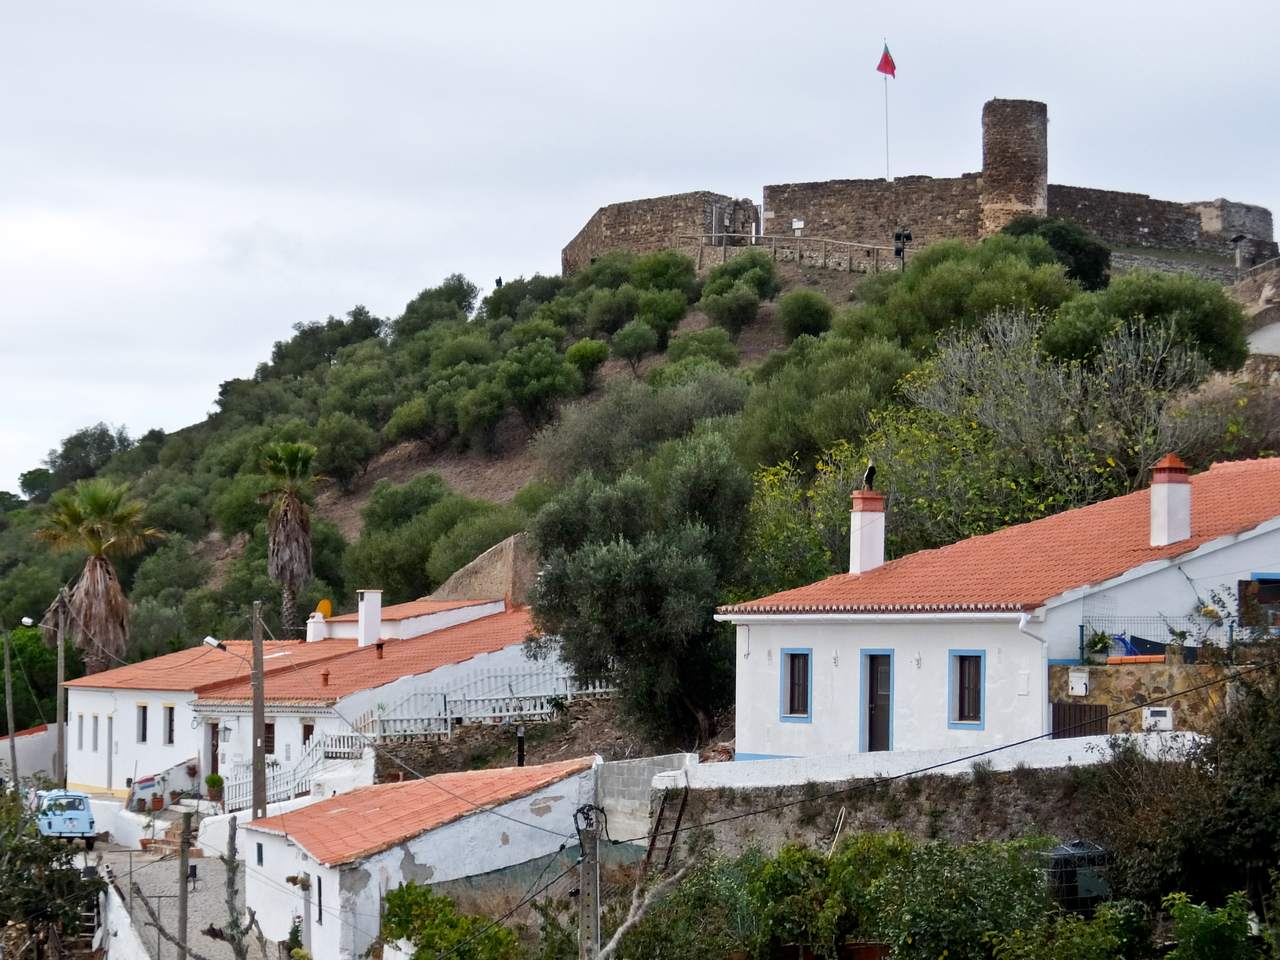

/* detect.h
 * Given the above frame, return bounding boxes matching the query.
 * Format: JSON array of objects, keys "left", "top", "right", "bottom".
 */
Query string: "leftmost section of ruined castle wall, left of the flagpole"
[{"left": 561, "top": 191, "right": 756, "bottom": 276}]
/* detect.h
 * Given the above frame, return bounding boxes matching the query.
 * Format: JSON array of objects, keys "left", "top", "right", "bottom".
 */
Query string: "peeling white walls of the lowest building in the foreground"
[{"left": 243, "top": 768, "right": 595, "bottom": 960}]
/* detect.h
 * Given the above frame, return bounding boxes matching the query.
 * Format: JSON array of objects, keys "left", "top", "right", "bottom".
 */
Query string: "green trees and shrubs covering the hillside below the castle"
[{"left": 0, "top": 220, "right": 1280, "bottom": 737}]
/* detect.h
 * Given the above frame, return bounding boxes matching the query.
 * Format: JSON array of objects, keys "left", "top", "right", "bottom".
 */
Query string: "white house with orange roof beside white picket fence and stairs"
[{"left": 193, "top": 604, "right": 572, "bottom": 809}]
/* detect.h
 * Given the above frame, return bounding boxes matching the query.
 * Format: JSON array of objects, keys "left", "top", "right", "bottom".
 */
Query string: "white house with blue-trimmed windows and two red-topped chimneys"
[{"left": 717, "top": 456, "right": 1280, "bottom": 759}]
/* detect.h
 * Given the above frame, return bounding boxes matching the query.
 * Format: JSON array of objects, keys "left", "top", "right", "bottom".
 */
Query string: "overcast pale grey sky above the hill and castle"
[{"left": 0, "top": 0, "right": 1280, "bottom": 489}]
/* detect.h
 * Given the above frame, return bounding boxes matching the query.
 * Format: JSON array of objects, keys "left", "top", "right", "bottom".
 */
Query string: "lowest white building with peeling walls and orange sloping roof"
[{"left": 241, "top": 758, "right": 598, "bottom": 960}]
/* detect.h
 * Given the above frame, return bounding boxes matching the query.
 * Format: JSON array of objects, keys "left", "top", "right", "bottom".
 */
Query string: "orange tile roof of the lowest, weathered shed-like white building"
[{"left": 247, "top": 756, "right": 594, "bottom": 867}]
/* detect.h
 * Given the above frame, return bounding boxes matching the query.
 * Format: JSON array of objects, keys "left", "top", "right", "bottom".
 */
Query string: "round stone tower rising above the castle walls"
[{"left": 982, "top": 100, "right": 1048, "bottom": 237}]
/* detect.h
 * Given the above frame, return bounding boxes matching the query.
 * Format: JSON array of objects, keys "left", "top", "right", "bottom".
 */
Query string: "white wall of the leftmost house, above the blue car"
[{"left": 67, "top": 686, "right": 204, "bottom": 796}]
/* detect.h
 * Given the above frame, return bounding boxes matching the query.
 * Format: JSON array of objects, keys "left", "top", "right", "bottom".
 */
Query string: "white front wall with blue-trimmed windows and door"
[{"left": 736, "top": 616, "right": 1048, "bottom": 759}]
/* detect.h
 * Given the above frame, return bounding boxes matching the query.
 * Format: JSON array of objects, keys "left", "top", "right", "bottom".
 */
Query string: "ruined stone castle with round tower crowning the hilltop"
[{"left": 562, "top": 100, "right": 1280, "bottom": 276}]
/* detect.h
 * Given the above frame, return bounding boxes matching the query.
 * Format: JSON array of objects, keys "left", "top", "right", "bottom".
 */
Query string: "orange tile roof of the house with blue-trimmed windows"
[{"left": 719, "top": 458, "right": 1280, "bottom": 614}]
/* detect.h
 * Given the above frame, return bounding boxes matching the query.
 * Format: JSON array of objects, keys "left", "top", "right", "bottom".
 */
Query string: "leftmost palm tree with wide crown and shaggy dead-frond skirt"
[{"left": 36, "top": 477, "right": 163, "bottom": 673}]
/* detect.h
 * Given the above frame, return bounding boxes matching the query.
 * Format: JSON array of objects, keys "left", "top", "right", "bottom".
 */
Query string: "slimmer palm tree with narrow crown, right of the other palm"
[{"left": 262, "top": 443, "right": 316, "bottom": 636}]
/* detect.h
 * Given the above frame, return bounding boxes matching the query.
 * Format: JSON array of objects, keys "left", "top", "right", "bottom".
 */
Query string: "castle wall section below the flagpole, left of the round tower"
[{"left": 764, "top": 173, "right": 980, "bottom": 248}]
